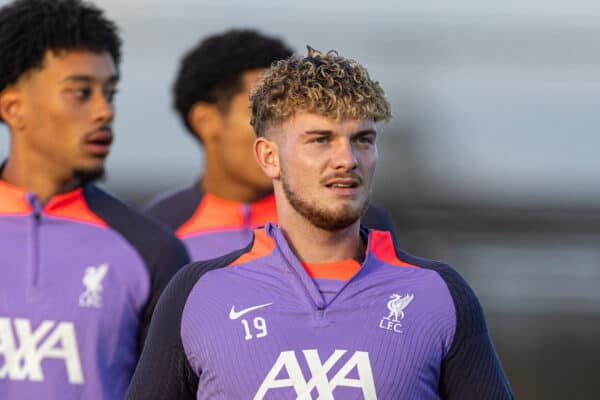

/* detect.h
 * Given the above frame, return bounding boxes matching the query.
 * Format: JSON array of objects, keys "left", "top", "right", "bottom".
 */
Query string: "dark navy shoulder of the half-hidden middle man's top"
[{"left": 142, "top": 183, "right": 204, "bottom": 231}]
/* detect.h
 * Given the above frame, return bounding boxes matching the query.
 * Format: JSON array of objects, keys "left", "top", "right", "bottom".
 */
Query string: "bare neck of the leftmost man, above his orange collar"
[{"left": 1, "top": 154, "right": 78, "bottom": 204}]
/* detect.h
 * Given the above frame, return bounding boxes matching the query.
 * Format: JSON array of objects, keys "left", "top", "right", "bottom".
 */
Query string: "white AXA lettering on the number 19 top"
[{"left": 254, "top": 349, "right": 377, "bottom": 400}]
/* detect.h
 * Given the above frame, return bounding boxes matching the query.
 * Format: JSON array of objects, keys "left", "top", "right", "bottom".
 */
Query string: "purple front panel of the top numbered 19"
[{"left": 181, "top": 224, "right": 456, "bottom": 399}]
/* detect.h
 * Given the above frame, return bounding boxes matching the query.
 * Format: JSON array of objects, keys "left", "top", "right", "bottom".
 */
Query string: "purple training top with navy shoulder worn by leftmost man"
[{"left": 0, "top": 181, "right": 189, "bottom": 400}]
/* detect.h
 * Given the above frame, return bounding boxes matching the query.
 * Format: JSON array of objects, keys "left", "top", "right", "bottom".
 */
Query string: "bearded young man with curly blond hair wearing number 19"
[{"left": 129, "top": 48, "right": 512, "bottom": 400}]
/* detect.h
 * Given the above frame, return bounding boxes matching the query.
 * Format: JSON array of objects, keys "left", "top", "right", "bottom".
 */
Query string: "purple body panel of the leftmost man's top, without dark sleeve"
[{"left": 0, "top": 198, "right": 150, "bottom": 400}]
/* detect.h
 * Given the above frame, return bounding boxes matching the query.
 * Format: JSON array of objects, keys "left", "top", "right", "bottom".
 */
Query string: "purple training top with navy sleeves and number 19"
[{"left": 128, "top": 224, "right": 512, "bottom": 400}]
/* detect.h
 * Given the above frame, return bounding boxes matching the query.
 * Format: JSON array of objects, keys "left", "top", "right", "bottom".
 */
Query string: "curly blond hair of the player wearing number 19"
[{"left": 250, "top": 46, "right": 391, "bottom": 136}]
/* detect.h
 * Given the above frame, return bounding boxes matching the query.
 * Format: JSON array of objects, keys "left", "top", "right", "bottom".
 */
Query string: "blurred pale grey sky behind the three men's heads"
[{"left": 0, "top": 0, "right": 600, "bottom": 209}]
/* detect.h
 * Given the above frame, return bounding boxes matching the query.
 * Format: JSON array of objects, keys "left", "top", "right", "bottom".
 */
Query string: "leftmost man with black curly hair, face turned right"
[{"left": 0, "top": 0, "right": 189, "bottom": 400}]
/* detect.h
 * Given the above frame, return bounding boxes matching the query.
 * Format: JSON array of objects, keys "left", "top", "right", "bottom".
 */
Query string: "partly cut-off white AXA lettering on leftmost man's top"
[{"left": 0, "top": 317, "right": 83, "bottom": 385}]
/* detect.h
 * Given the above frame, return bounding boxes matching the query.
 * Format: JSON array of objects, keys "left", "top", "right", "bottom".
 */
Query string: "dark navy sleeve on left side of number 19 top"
[{"left": 126, "top": 264, "right": 199, "bottom": 400}]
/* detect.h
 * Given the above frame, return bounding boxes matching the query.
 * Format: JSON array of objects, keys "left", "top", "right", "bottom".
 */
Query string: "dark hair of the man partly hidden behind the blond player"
[{"left": 173, "top": 29, "right": 293, "bottom": 136}]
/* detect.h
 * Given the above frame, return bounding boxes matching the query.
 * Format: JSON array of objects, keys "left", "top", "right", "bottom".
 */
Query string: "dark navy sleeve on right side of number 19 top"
[{"left": 436, "top": 265, "right": 514, "bottom": 400}]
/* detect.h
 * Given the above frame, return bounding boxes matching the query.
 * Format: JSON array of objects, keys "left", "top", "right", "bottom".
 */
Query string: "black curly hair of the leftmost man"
[{"left": 0, "top": 0, "right": 121, "bottom": 91}]
